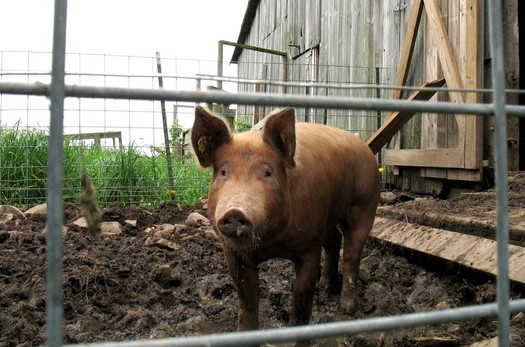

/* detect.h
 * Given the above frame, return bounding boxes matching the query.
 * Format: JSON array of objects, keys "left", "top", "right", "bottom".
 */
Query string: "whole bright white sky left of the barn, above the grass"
[{"left": 0, "top": 0, "right": 248, "bottom": 145}]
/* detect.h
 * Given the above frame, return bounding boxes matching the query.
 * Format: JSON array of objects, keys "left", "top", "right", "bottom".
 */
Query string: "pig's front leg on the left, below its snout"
[{"left": 225, "top": 250, "right": 259, "bottom": 331}]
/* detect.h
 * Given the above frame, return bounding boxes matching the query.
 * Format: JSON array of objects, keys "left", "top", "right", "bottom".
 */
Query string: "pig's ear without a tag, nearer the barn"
[{"left": 263, "top": 108, "right": 295, "bottom": 167}]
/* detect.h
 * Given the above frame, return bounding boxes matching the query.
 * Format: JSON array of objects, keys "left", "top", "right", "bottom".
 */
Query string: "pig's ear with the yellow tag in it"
[{"left": 191, "top": 106, "right": 232, "bottom": 167}]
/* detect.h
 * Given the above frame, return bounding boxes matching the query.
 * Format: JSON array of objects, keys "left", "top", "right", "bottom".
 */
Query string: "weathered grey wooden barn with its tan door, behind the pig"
[{"left": 227, "top": 0, "right": 525, "bottom": 194}]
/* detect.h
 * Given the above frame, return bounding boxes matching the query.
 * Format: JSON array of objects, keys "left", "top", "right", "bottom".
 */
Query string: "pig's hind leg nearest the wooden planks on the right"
[{"left": 340, "top": 203, "right": 377, "bottom": 314}]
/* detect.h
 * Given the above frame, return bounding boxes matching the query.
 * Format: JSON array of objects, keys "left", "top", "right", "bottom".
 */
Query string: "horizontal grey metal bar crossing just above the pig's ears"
[{"left": 0, "top": 82, "right": 525, "bottom": 117}]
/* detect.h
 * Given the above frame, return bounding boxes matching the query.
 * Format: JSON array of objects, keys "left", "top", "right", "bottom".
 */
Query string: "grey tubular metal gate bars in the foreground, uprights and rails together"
[{"left": 0, "top": 0, "right": 525, "bottom": 346}]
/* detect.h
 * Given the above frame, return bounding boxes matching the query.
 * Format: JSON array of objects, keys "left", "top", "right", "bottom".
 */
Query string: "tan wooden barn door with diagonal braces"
[{"left": 385, "top": 0, "right": 483, "bottom": 181}]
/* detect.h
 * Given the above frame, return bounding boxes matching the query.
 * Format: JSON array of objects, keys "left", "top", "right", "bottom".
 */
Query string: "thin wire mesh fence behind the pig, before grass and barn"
[{"left": 0, "top": 51, "right": 402, "bottom": 207}]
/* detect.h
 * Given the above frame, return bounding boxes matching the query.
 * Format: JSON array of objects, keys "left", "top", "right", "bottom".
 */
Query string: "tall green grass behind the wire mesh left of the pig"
[{"left": 0, "top": 124, "right": 211, "bottom": 207}]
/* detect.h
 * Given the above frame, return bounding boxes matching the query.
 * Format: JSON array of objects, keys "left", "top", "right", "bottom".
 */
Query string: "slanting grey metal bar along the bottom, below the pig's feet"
[{"left": 65, "top": 299, "right": 525, "bottom": 347}]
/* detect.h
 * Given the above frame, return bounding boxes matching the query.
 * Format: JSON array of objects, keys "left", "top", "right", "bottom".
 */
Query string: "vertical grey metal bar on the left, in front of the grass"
[{"left": 46, "top": 0, "right": 67, "bottom": 347}]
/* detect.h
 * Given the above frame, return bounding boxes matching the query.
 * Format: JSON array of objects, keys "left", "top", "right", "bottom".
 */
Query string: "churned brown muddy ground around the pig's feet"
[{"left": 0, "top": 173, "right": 525, "bottom": 346}]
